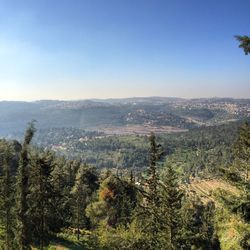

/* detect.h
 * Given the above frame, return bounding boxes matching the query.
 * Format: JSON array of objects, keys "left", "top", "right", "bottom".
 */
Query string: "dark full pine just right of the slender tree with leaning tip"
[{"left": 28, "top": 152, "right": 55, "bottom": 249}]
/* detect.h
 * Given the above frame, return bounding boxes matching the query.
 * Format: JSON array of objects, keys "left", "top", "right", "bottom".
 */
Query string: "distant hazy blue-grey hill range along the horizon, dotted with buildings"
[{"left": 0, "top": 97, "right": 250, "bottom": 136}]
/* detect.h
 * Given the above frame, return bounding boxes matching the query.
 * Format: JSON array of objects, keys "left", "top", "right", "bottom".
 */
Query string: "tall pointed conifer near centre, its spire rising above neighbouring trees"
[{"left": 138, "top": 133, "right": 169, "bottom": 249}]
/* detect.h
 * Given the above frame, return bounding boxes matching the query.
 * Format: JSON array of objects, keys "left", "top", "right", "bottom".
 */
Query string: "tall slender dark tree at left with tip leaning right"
[{"left": 17, "top": 122, "right": 35, "bottom": 250}]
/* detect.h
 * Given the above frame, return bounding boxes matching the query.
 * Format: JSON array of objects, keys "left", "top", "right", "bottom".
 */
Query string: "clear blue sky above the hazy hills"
[{"left": 0, "top": 0, "right": 250, "bottom": 100}]
